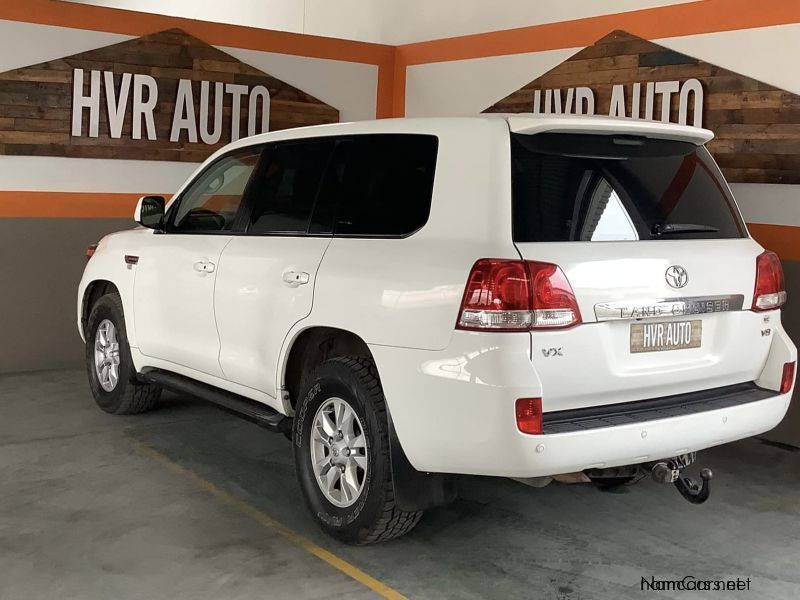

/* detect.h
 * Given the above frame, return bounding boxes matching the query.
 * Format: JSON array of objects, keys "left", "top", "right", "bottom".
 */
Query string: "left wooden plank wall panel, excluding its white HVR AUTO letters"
[{"left": 0, "top": 29, "right": 339, "bottom": 162}]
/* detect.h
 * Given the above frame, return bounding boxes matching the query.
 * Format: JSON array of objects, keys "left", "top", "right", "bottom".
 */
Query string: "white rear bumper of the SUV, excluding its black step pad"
[{"left": 371, "top": 328, "right": 796, "bottom": 477}]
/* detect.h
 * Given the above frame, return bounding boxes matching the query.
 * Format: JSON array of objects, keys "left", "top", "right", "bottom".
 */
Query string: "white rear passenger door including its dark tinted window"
[{"left": 214, "top": 138, "right": 337, "bottom": 398}]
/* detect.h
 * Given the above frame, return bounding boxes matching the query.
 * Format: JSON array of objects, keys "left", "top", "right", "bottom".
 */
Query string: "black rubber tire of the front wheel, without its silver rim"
[{"left": 86, "top": 293, "right": 161, "bottom": 415}]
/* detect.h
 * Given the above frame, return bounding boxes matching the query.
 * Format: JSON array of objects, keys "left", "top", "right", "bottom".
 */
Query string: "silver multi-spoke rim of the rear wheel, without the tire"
[{"left": 311, "top": 398, "right": 368, "bottom": 508}]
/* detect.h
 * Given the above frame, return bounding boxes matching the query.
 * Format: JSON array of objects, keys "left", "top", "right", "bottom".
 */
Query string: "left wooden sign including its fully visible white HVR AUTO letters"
[{"left": 0, "top": 29, "right": 339, "bottom": 162}]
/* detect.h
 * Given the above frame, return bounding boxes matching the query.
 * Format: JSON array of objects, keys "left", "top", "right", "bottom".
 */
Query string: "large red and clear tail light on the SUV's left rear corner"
[{"left": 456, "top": 258, "right": 581, "bottom": 331}]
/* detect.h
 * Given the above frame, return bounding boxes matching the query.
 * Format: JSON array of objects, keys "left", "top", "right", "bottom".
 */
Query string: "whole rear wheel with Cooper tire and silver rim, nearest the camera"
[{"left": 294, "top": 356, "right": 422, "bottom": 544}]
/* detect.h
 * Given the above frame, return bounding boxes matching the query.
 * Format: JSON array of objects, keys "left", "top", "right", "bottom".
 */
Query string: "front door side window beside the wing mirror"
[{"left": 170, "top": 146, "right": 262, "bottom": 233}]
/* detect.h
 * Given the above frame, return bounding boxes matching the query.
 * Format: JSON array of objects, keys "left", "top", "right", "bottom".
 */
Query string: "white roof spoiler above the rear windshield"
[{"left": 506, "top": 114, "right": 714, "bottom": 146}]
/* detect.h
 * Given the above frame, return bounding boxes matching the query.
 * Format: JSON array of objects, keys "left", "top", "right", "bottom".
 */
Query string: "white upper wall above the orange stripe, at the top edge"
[{"left": 67, "top": 0, "right": 693, "bottom": 45}]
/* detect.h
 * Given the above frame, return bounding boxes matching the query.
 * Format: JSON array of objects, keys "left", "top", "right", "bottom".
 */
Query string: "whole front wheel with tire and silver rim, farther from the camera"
[{"left": 86, "top": 294, "right": 161, "bottom": 415}]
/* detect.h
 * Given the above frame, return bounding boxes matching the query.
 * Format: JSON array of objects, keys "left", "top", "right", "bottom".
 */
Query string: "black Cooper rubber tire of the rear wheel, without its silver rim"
[{"left": 294, "top": 356, "right": 422, "bottom": 545}]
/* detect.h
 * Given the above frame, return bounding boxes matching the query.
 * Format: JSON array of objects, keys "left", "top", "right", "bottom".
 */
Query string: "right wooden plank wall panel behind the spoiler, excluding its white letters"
[{"left": 485, "top": 31, "right": 800, "bottom": 184}]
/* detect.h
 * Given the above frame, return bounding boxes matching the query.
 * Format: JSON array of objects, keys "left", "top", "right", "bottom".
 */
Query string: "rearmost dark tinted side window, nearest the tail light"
[{"left": 336, "top": 134, "right": 438, "bottom": 236}]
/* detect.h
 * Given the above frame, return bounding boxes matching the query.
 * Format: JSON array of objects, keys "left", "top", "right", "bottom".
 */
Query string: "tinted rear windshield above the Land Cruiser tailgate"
[{"left": 511, "top": 133, "right": 746, "bottom": 242}]
